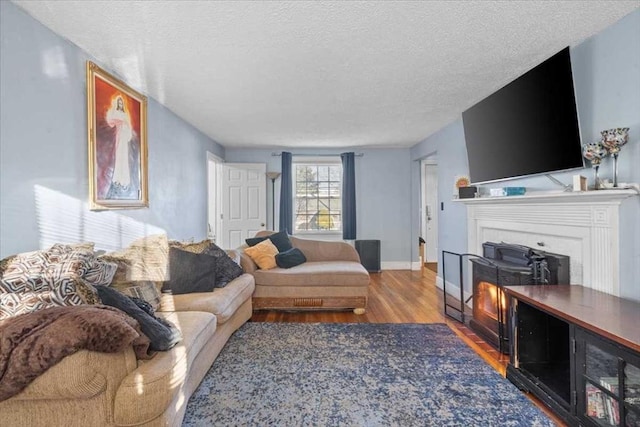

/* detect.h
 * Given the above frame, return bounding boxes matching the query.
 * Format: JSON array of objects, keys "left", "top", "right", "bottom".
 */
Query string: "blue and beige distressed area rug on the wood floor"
[{"left": 183, "top": 323, "right": 555, "bottom": 426}]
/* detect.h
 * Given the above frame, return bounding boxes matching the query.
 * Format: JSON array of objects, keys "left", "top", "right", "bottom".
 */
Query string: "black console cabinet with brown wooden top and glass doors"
[{"left": 504, "top": 285, "right": 640, "bottom": 426}]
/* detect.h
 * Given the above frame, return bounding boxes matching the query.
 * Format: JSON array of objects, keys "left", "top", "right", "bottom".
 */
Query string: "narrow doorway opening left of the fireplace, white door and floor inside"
[{"left": 419, "top": 157, "right": 438, "bottom": 273}]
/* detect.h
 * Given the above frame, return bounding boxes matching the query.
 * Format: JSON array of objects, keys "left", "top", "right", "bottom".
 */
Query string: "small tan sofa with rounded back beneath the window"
[{"left": 241, "top": 231, "right": 370, "bottom": 314}]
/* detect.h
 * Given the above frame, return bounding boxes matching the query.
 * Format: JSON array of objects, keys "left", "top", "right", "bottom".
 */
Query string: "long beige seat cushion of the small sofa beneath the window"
[{"left": 253, "top": 261, "right": 369, "bottom": 286}]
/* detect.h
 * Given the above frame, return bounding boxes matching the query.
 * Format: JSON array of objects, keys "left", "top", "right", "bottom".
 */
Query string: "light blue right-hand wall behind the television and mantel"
[{"left": 411, "top": 10, "right": 640, "bottom": 299}]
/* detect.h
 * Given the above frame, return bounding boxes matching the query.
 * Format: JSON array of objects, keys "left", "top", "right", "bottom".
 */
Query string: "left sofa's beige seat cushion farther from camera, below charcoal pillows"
[{"left": 160, "top": 274, "right": 255, "bottom": 324}]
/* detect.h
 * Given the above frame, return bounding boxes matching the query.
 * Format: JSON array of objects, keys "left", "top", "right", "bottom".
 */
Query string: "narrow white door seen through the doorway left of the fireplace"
[{"left": 423, "top": 159, "right": 438, "bottom": 262}]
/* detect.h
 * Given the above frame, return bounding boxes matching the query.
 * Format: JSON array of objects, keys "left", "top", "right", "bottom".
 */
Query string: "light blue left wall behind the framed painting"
[{"left": 0, "top": 1, "right": 224, "bottom": 257}]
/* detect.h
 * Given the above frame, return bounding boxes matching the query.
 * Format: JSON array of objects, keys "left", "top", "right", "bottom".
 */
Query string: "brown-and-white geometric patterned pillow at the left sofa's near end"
[{"left": 0, "top": 245, "right": 100, "bottom": 320}]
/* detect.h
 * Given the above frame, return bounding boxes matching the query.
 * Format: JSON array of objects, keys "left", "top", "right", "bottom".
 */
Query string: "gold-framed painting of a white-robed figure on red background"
[{"left": 87, "top": 61, "right": 149, "bottom": 210}]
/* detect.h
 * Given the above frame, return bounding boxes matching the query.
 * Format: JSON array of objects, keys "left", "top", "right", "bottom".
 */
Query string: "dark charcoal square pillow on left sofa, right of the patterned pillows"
[{"left": 162, "top": 247, "right": 216, "bottom": 295}]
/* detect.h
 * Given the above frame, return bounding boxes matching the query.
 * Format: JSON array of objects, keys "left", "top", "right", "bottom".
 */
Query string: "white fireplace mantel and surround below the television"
[{"left": 457, "top": 189, "right": 638, "bottom": 296}]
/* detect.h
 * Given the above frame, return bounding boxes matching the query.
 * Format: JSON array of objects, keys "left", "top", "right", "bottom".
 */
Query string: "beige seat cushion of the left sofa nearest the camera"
[{"left": 113, "top": 311, "right": 217, "bottom": 425}]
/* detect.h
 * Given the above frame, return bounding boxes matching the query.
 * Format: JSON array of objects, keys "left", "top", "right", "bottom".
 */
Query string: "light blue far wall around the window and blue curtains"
[{"left": 225, "top": 147, "right": 418, "bottom": 268}]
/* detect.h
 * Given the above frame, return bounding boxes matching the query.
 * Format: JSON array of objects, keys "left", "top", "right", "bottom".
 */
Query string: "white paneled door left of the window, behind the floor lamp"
[{"left": 218, "top": 163, "right": 267, "bottom": 249}]
